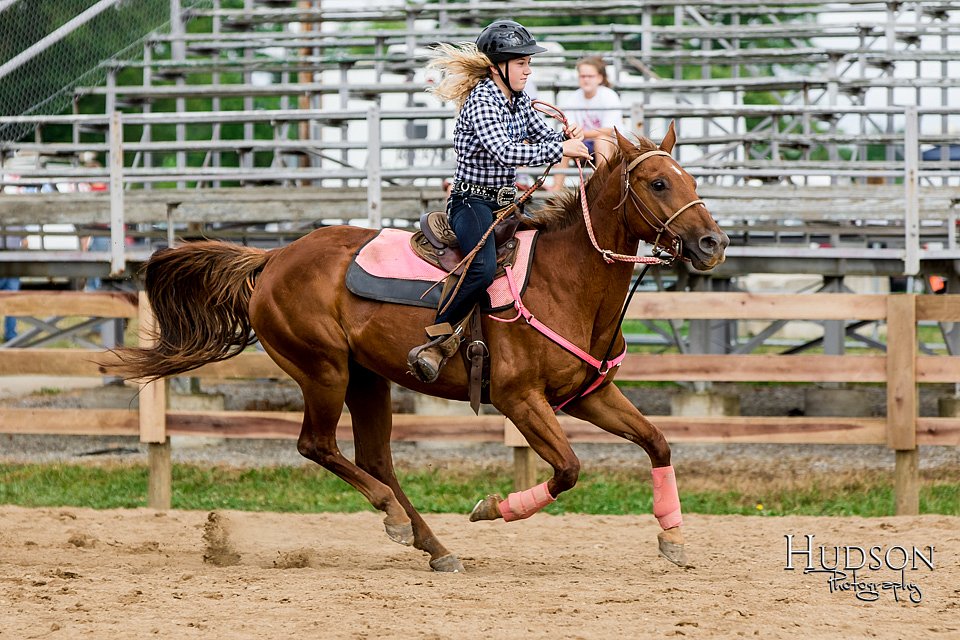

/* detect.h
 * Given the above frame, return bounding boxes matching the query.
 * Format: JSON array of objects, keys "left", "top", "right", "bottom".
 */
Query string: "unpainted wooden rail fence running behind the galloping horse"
[{"left": 0, "top": 292, "right": 960, "bottom": 514}]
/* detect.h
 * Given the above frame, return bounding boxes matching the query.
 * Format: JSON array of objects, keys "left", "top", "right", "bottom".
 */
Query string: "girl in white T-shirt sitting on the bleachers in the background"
[{"left": 552, "top": 56, "right": 623, "bottom": 190}]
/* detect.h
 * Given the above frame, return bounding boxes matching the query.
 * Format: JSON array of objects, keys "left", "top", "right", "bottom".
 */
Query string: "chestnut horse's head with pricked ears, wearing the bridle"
[{"left": 616, "top": 122, "right": 730, "bottom": 271}]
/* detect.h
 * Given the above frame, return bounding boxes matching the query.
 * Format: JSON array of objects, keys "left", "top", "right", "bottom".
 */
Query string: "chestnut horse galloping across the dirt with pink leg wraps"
[{"left": 109, "top": 123, "right": 729, "bottom": 571}]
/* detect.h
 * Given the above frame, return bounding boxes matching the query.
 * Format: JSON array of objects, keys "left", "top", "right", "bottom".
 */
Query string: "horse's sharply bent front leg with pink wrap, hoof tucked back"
[{"left": 470, "top": 393, "right": 580, "bottom": 522}]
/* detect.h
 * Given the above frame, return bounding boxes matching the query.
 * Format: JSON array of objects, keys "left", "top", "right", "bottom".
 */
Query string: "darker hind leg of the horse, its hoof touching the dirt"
[{"left": 346, "top": 363, "right": 463, "bottom": 572}]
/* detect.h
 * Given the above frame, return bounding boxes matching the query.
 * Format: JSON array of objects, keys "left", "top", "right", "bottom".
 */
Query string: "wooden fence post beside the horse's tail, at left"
[{"left": 137, "top": 291, "right": 172, "bottom": 509}]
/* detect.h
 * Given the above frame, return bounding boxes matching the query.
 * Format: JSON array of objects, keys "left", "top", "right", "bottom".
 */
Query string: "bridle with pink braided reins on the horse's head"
[{"left": 531, "top": 100, "right": 705, "bottom": 265}]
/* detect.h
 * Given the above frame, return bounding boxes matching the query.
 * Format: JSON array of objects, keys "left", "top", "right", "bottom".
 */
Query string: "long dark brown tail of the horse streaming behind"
[{"left": 101, "top": 241, "right": 270, "bottom": 380}]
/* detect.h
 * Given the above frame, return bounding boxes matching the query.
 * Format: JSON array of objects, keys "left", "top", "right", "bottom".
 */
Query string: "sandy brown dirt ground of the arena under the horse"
[{"left": 0, "top": 506, "right": 960, "bottom": 640}]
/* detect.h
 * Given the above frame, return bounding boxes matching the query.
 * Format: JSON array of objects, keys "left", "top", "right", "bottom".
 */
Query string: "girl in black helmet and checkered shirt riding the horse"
[{"left": 407, "top": 20, "right": 589, "bottom": 382}]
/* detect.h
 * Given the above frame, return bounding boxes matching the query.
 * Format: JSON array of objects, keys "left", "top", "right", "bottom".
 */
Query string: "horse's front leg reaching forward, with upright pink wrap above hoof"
[{"left": 563, "top": 383, "right": 687, "bottom": 567}]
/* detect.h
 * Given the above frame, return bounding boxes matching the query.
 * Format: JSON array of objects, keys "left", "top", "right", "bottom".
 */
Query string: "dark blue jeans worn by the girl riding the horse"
[{"left": 437, "top": 193, "right": 500, "bottom": 325}]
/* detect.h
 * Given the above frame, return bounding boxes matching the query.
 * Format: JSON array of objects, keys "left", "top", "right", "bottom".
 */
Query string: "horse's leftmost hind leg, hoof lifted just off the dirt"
[{"left": 297, "top": 378, "right": 413, "bottom": 545}]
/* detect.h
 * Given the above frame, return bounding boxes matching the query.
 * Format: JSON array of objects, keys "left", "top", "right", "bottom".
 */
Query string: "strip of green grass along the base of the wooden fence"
[{"left": 0, "top": 464, "right": 960, "bottom": 516}]
